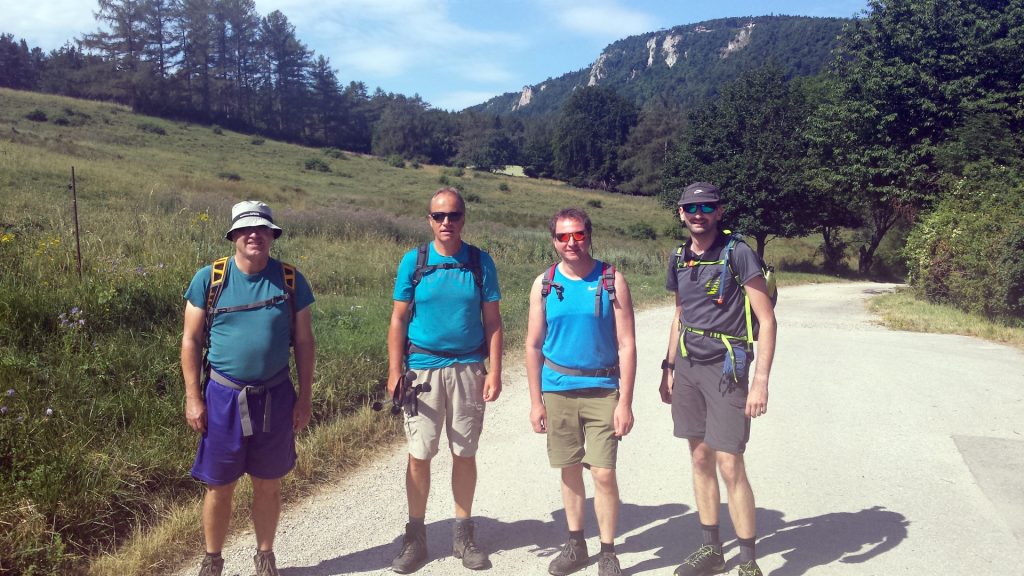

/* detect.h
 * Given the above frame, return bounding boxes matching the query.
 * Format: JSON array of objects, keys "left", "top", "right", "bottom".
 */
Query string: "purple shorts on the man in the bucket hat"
[{"left": 191, "top": 373, "right": 296, "bottom": 486}]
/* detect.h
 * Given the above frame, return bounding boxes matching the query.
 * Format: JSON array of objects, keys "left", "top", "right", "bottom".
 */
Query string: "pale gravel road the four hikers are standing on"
[{"left": 178, "top": 283, "right": 1024, "bottom": 576}]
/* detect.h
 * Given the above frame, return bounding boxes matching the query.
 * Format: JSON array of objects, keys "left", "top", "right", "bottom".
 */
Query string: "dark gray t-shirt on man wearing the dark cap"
[{"left": 665, "top": 235, "right": 761, "bottom": 362}]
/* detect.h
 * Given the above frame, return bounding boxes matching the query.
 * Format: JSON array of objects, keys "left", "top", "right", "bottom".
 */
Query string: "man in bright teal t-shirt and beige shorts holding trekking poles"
[{"left": 387, "top": 188, "right": 503, "bottom": 574}]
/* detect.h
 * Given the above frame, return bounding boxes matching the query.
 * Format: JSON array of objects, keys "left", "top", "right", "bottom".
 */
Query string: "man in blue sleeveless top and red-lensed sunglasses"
[{"left": 526, "top": 208, "right": 637, "bottom": 576}]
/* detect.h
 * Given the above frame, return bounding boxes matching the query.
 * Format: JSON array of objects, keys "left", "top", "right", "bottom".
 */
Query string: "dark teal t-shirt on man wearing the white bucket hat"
[{"left": 184, "top": 258, "right": 313, "bottom": 382}]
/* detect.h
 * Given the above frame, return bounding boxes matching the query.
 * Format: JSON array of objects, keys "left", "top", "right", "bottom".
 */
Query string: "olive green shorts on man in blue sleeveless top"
[{"left": 544, "top": 388, "right": 620, "bottom": 469}]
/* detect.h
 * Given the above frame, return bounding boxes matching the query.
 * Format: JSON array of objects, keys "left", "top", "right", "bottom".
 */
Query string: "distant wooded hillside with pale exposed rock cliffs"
[{"left": 469, "top": 16, "right": 850, "bottom": 116}]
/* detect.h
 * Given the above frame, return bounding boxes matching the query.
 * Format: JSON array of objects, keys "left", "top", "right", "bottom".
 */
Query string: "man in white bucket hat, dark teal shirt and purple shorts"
[{"left": 181, "top": 201, "right": 315, "bottom": 576}]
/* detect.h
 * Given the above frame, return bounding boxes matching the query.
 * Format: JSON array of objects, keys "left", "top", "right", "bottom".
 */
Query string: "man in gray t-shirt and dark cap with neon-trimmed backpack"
[{"left": 660, "top": 182, "right": 775, "bottom": 576}]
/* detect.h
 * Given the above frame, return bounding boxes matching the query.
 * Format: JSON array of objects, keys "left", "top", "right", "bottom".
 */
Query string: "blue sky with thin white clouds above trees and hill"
[{"left": 6, "top": 0, "right": 867, "bottom": 110}]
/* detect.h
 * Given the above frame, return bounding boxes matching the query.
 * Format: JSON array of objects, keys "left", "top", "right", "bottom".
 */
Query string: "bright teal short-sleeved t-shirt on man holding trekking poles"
[{"left": 393, "top": 242, "right": 502, "bottom": 369}]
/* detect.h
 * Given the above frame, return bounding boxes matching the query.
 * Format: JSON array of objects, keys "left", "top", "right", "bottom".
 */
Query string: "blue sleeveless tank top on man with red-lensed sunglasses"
[{"left": 541, "top": 260, "right": 618, "bottom": 392}]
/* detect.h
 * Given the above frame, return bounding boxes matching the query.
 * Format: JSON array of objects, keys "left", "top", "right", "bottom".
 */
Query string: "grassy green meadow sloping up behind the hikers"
[{"left": 0, "top": 89, "right": 825, "bottom": 575}]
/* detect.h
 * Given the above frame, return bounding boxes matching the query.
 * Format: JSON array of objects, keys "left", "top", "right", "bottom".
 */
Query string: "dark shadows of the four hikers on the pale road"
[{"left": 281, "top": 498, "right": 910, "bottom": 576}]
